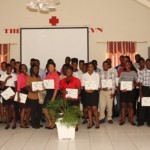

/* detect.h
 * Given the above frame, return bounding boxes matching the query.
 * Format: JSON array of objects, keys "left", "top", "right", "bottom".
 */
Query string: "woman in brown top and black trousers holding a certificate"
[{"left": 26, "top": 65, "right": 42, "bottom": 129}]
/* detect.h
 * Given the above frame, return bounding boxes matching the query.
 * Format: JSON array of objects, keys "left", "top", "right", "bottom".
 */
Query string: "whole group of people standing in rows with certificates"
[{"left": 0, "top": 54, "right": 150, "bottom": 130}]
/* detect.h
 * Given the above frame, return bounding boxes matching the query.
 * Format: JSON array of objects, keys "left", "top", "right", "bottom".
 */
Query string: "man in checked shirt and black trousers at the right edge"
[{"left": 138, "top": 59, "right": 150, "bottom": 127}]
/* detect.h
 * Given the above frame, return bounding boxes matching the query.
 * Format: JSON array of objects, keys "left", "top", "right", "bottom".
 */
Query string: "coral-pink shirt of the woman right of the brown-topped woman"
[{"left": 44, "top": 71, "right": 59, "bottom": 90}]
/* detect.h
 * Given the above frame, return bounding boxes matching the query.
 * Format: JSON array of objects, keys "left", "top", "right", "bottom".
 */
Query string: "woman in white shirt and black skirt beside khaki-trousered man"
[{"left": 82, "top": 62, "right": 100, "bottom": 129}]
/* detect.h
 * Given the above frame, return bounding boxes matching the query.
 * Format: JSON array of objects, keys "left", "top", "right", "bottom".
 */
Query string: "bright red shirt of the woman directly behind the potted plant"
[{"left": 59, "top": 76, "right": 81, "bottom": 100}]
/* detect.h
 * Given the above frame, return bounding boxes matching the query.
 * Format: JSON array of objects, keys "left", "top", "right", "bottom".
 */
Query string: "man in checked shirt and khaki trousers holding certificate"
[{"left": 100, "top": 61, "right": 115, "bottom": 124}]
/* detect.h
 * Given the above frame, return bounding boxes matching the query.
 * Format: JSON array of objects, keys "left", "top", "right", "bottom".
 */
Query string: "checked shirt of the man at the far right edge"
[{"left": 139, "top": 69, "right": 150, "bottom": 86}]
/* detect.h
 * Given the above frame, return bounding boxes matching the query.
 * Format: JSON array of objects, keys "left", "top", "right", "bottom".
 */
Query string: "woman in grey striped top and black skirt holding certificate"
[{"left": 119, "top": 61, "right": 138, "bottom": 125}]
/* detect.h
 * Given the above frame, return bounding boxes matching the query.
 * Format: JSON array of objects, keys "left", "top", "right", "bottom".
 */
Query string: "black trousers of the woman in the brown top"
[{"left": 30, "top": 99, "right": 42, "bottom": 127}]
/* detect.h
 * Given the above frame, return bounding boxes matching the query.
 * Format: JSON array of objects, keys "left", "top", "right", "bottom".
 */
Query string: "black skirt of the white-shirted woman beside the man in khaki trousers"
[{"left": 85, "top": 90, "right": 99, "bottom": 106}]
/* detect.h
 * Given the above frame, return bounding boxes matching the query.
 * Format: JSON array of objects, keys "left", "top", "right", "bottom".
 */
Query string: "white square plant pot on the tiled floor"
[{"left": 56, "top": 119, "right": 75, "bottom": 140}]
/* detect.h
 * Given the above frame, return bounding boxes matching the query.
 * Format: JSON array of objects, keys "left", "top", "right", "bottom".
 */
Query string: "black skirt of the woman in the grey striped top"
[{"left": 120, "top": 89, "right": 136, "bottom": 104}]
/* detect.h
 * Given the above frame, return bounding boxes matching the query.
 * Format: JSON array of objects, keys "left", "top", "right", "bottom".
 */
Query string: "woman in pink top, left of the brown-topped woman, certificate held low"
[{"left": 17, "top": 64, "right": 29, "bottom": 128}]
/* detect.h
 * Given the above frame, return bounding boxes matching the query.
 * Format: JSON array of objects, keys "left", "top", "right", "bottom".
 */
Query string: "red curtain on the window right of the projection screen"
[{"left": 107, "top": 41, "right": 136, "bottom": 66}]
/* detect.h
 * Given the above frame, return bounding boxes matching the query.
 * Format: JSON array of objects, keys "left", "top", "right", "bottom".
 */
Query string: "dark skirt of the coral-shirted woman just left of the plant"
[{"left": 43, "top": 89, "right": 54, "bottom": 108}]
